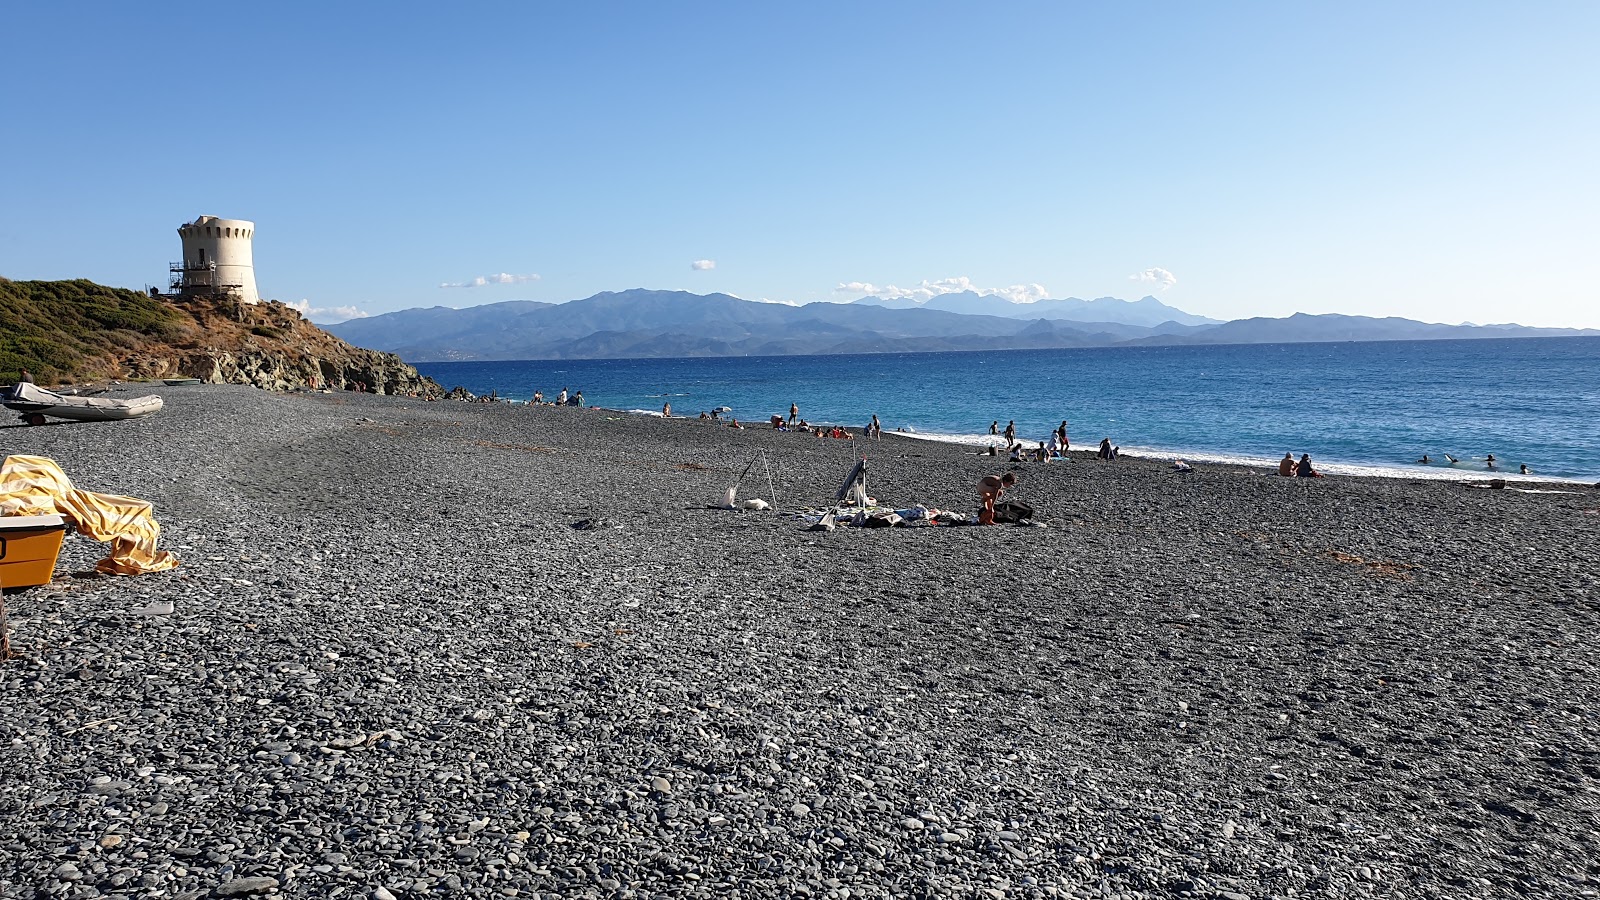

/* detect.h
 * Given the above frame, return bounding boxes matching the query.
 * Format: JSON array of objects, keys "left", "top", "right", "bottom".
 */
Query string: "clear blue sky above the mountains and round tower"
[{"left": 0, "top": 3, "right": 1600, "bottom": 327}]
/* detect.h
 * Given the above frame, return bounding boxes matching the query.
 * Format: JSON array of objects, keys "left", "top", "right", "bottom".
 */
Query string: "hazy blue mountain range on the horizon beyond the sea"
[{"left": 325, "top": 288, "right": 1600, "bottom": 362}]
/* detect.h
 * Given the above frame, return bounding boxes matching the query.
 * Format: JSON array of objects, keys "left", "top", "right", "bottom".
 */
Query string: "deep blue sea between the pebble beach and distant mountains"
[{"left": 418, "top": 338, "right": 1600, "bottom": 482}]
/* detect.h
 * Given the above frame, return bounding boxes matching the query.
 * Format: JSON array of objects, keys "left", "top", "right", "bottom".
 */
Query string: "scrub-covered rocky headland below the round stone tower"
[{"left": 0, "top": 279, "right": 445, "bottom": 397}]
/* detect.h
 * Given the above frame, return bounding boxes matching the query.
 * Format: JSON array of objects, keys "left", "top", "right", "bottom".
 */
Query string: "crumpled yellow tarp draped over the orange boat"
[{"left": 0, "top": 456, "right": 178, "bottom": 575}]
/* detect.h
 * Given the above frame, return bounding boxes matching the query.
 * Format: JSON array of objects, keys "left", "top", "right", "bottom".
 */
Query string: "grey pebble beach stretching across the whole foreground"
[{"left": 0, "top": 386, "right": 1600, "bottom": 900}]
